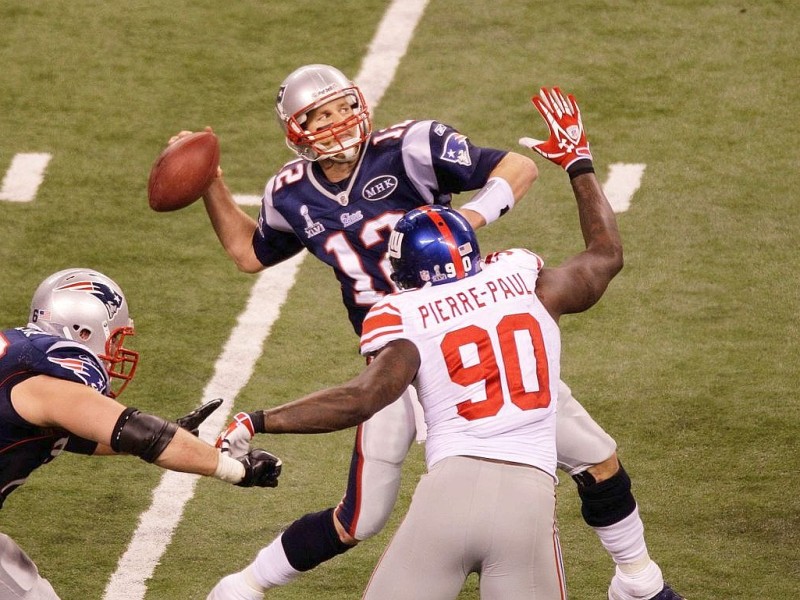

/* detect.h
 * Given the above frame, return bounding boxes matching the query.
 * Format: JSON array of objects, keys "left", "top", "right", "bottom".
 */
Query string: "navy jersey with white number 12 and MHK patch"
[{"left": 253, "top": 121, "right": 507, "bottom": 335}]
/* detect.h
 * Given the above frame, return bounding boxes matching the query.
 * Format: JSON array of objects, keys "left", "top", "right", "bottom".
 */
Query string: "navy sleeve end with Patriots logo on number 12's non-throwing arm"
[{"left": 430, "top": 121, "right": 508, "bottom": 194}]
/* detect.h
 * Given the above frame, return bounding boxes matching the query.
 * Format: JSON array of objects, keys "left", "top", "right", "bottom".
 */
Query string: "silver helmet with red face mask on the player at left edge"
[{"left": 30, "top": 269, "right": 139, "bottom": 398}]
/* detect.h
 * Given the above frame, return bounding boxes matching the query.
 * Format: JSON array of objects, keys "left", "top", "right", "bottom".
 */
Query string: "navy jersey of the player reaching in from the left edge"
[{"left": 0, "top": 327, "right": 109, "bottom": 507}]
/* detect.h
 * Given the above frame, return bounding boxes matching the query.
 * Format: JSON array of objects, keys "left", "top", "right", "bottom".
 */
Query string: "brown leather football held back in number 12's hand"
[{"left": 147, "top": 131, "right": 219, "bottom": 212}]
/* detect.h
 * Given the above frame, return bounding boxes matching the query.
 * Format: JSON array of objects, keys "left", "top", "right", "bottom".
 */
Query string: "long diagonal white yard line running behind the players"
[{"left": 103, "top": 0, "right": 428, "bottom": 600}]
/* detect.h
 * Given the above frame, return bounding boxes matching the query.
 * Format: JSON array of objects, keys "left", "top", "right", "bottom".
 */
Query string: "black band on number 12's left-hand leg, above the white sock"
[{"left": 281, "top": 508, "right": 352, "bottom": 571}]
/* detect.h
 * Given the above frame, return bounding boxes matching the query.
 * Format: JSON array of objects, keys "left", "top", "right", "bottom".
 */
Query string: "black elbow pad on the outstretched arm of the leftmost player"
[{"left": 111, "top": 408, "right": 178, "bottom": 462}]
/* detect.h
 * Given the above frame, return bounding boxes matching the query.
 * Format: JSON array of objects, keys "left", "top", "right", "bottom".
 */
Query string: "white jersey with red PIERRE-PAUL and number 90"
[{"left": 361, "top": 249, "right": 561, "bottom": 477}]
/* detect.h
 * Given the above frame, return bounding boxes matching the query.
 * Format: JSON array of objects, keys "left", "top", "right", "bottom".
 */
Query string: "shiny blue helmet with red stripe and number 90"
[{"left": 389, "top": 206, "right": 481, "bottom": 289}]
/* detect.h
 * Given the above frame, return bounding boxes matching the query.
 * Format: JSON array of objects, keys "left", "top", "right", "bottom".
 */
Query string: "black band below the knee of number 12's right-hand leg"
[{"left": 573, "top": 464, "right": 636, "bottom": 527}]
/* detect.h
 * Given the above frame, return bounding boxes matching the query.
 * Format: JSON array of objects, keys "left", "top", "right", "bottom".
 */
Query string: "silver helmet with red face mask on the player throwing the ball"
[{"left": 275, "top": 65, "right": 372, "bottom": 162}]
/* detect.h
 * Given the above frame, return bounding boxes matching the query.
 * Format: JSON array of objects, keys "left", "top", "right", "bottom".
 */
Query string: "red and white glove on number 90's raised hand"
[{"left": 519, "top": 87, "right": 592, "bottom": 171}]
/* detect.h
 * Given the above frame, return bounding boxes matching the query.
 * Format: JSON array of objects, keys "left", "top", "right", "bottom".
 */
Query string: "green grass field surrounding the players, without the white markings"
[{"left": 0, "top": 0, "right": 800, "bottom": 600}]
